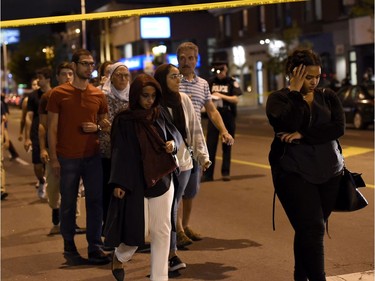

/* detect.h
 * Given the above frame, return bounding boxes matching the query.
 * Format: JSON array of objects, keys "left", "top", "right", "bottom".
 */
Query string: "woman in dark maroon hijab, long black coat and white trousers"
[{"left": 104, "top": 74, "right": 182, "bottom": 281}]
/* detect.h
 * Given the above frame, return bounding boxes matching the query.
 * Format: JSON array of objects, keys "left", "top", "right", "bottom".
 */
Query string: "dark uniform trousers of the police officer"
[{"left": 204, "top": 109, "right": 236, "bottom": 178}]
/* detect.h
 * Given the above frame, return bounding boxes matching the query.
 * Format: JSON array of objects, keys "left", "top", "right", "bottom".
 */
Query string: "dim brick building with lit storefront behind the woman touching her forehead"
[{"left": 210, "top": 0, "right": 374, "bottom": 104}]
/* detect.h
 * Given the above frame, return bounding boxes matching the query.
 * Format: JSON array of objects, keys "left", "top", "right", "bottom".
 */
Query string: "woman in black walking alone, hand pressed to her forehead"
[{"left": 266, "top": 50, "right": 345, "bottom": 281}]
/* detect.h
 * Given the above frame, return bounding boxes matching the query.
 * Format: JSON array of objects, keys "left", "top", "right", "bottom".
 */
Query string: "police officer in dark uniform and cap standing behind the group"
[{"left": 202, "top": 61, "right": 242, "bottom": 181}]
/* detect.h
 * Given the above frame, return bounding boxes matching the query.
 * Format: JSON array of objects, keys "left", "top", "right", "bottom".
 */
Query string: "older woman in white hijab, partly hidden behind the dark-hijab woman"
[{"left": 99, "top": 62, "right": 131, "bottom": 230}]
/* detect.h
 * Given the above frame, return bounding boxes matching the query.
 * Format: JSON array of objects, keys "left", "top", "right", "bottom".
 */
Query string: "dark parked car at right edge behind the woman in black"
[{"left": 337, "top": 85, "right": 374, "bottom": 129}]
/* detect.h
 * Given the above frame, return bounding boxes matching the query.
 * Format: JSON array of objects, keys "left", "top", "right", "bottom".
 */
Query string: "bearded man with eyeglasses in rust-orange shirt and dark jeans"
[{"left": 47, "top": 49, "right": 110, "bottom": 264}]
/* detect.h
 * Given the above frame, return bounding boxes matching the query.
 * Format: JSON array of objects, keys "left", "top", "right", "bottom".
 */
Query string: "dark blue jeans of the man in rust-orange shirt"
[{"left": 59, "top": 155, "right": 103, "bottom": 253}]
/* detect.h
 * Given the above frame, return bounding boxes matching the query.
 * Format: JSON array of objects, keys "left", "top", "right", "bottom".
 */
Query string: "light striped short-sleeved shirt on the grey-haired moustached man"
[{"left": 180, "top": 76, "right": 212, "bottom": 121}]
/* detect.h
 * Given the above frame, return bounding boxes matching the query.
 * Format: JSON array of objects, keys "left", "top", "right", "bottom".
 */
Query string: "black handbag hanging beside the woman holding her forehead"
[{"left": 333, "top": 167, "right": 368, "bottom": 212}]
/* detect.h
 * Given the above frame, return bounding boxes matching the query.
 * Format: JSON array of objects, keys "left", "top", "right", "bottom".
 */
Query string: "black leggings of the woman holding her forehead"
[{"left": 275, "top": 172, "right": 341, "bottom": 281}]
